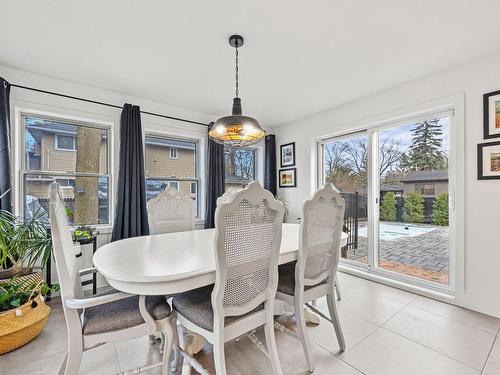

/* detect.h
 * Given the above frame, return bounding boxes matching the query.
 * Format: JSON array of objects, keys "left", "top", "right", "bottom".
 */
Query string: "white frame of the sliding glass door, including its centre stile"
[{"left": 310, "top": 94, "right": 465, "bottom": 295}]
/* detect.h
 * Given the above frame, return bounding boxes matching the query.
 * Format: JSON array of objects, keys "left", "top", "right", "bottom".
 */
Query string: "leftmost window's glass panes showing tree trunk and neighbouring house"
[{"left": 21, "top": 114, "right": 111, "bottom": 225}]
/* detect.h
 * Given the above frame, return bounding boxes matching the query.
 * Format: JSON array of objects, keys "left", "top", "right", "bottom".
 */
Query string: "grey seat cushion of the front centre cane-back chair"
[{"left": 172, "top": 284, "right": 264, "bottom": 332}]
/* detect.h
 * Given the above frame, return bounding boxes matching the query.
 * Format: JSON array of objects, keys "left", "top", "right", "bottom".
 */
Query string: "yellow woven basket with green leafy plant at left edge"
[{"left": 0, "top": 278, "right": 59, "bottom": 355}]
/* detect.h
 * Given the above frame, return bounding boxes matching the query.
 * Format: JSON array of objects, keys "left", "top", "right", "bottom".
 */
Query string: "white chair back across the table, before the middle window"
[{"left": 147, "top": 187, "right": 195, "bottom": 234}]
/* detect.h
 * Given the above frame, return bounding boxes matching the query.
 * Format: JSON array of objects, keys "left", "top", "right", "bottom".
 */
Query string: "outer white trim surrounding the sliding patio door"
[{"left": 310, "top": 93, "right": 466, "bottom": 301}]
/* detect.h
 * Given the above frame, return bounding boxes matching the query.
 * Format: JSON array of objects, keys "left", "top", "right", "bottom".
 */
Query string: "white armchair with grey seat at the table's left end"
[{"left": 50, "top": 183, "right": 175, "bottom": 375}]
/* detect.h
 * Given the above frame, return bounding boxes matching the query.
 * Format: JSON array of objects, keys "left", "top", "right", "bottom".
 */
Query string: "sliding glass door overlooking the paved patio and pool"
[{"left": 318, "top": 113, "right": 452, "bottom": 290}]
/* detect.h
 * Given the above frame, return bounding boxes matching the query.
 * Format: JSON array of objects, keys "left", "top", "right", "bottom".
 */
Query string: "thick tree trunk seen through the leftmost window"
[{"left": 74, "top": 126, "right": 101, "bottom": 225}]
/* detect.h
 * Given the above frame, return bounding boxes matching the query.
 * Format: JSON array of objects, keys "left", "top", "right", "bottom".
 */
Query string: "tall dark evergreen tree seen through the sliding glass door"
[{"left": 403, "top": 119, "right": 448, "bottom": 171}]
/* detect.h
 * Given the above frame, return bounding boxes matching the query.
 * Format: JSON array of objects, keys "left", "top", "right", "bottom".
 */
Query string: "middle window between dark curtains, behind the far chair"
[{"left": 144, "top": 135, "right": 200, "bottom": 217}]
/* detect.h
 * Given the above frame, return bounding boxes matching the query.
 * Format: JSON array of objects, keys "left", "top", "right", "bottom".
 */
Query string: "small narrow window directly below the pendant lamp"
[{"left": 224, "top": 148, "right": 255, "bottom": 190}]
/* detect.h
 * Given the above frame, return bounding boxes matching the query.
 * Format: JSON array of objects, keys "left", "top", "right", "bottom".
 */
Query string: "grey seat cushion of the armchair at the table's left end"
[{"left": 83, "top": 296, "right": 171, "bottom": 335}]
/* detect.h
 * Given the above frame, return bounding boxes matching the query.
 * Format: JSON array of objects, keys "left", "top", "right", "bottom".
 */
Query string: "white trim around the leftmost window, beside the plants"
[{"left": 15, "top": 107, "right": 115, "bottom": 228}]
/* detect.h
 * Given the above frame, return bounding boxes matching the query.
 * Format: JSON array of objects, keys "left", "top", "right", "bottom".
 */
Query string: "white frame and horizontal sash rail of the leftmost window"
[{"left": 18, "top": 111, "right": 114, "bottom": 229}]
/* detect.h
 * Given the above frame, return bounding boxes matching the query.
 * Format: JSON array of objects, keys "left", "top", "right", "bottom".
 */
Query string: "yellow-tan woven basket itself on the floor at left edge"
[{"left": 0, "top": 295, "right": 50, "bottom": 354}]
